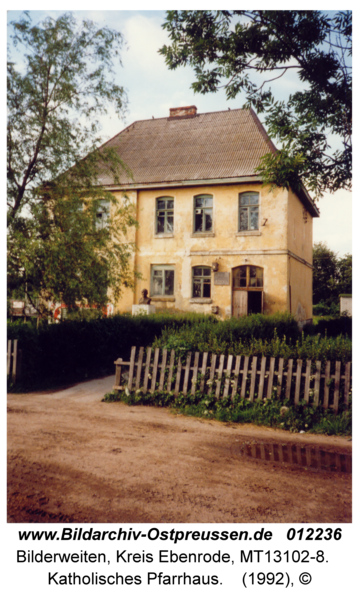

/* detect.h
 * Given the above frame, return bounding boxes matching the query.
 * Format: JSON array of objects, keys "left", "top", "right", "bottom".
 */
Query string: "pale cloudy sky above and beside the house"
[{"left": 8, "top": 3, "right": 352, "bottom": 255}]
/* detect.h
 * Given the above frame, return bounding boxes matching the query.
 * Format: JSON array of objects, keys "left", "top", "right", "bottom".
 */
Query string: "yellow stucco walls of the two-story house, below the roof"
[{"left": 109, "top": 181, "right": 312, "bottom": 320}]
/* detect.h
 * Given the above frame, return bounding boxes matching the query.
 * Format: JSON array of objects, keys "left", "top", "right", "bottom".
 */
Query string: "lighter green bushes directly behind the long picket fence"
[{"left": 153, "top": 313, "right": 352, "bottom": 362}]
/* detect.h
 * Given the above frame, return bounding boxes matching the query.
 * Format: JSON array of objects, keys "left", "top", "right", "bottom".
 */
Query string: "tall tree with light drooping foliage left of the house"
[{"left": 7, "top": 13, "right": 136, "bottom": 315}]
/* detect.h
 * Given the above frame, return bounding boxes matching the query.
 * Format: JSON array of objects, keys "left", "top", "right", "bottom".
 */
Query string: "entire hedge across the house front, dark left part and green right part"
[{"left": 8, "top": 313, "right": 351, "bottom": 389}]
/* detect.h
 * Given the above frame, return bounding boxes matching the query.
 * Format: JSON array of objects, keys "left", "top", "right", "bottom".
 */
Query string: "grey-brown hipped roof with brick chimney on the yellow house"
[{"left": 101, "top": 107, "right": 320, "bottom": 217}]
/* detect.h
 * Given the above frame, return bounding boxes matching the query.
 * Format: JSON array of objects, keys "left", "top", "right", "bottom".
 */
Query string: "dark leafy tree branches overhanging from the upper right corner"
[{"left": 159, "top": 10, "right": 352, "bottom": 196}]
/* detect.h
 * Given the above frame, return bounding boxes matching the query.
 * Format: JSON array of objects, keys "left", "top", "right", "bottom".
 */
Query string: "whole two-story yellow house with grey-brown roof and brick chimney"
[{"left": 101, "top": 106, "right": 319, "bottom": 320}]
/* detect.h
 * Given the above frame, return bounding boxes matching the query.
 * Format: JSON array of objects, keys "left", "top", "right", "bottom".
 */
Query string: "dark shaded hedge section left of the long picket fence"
[{"left": 7, "top": 311, "right": 215, "bottom": 390}]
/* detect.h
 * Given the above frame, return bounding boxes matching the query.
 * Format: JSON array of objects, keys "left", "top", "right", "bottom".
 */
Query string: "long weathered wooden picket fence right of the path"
[{"left": 114, "top": 346, "right": 352, "bottom": 414}]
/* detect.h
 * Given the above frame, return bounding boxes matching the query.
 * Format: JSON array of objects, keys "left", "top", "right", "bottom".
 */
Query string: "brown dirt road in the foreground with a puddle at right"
[{"left": 8, "top": 377, "right": 351, "bottom": 523}]
